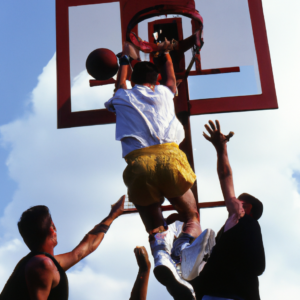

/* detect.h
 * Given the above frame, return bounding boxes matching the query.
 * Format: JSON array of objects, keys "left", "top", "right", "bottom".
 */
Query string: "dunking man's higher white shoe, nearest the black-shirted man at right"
[{"left": 181, "top": 229, "right": 215, "bottom": 281}]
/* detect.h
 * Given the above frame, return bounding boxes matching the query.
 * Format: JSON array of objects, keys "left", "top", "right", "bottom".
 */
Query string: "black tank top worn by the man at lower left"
[{"left": 0, "top": 252, "right": 69, "bottom": 300}]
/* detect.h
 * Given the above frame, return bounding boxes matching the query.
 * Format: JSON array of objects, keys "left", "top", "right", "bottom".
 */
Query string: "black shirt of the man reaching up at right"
[{"left": 191, "top": 215, "right": 265, "bottom": 300}]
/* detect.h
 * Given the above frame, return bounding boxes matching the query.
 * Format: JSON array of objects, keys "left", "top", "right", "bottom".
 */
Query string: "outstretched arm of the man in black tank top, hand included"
[{"left": 55, "top": 196, "right": 125, "bottom": 271}]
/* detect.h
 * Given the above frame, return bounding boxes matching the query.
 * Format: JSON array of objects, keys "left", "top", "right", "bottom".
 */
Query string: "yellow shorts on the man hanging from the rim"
[{"left": 123, "top": 143, "right": 196, "bottom": 206}]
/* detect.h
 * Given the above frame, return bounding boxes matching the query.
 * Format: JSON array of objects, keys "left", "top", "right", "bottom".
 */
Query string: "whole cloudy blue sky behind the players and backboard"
[{"left": 0, "top": 0, "right": 300, "bottom": 300}]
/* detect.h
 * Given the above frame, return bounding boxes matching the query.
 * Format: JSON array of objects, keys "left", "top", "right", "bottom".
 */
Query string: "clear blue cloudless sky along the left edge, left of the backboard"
[{"left": 0, "top": 0, "right": 56, "bottom": 211}]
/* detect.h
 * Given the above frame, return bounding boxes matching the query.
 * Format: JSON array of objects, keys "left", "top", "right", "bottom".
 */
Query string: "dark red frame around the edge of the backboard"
[{"left": 56, "top": 0, "right": 278, "bottom": 128}]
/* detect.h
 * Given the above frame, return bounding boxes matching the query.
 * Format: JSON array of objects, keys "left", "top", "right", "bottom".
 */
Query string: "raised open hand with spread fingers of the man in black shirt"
[{"left": 203, "top": 120, "right": 234, "bottom": 150}]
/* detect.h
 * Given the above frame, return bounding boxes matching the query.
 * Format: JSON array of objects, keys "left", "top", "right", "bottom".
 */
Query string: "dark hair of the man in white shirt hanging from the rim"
[{"left": 131, "top": 61, "right": 159, "bottom": 84}]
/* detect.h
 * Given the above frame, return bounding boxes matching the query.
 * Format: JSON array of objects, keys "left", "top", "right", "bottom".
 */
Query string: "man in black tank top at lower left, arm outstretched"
[{"left": 0, "top": 196, "right": 125, "bottom": 300}]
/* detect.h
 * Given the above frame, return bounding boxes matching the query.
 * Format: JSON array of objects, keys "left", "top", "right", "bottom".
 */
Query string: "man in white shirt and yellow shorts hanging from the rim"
[{"left": 105, "top": 38, "right": 201, "bottom": 299}]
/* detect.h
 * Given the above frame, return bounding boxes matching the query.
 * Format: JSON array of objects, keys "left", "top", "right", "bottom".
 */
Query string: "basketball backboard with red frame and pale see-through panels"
[{"left": 56, "top": 0, "right": 277, "bottom": 128}]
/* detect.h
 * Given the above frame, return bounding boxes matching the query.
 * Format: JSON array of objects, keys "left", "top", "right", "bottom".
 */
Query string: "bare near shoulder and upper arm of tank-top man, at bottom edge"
[{"left": 25, "top": 255, "right": 55, "bottom": 300}]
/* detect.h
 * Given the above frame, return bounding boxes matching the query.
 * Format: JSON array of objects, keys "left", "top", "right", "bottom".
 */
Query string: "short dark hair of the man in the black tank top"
[{"left": 18, "top": 205, "right": 52, "bottom": 250}]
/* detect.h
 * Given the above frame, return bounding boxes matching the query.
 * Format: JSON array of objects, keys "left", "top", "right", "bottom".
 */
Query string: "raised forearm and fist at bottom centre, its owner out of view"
[{"left": 129, "top": 247, "right": 151, "bottom": 300}]
